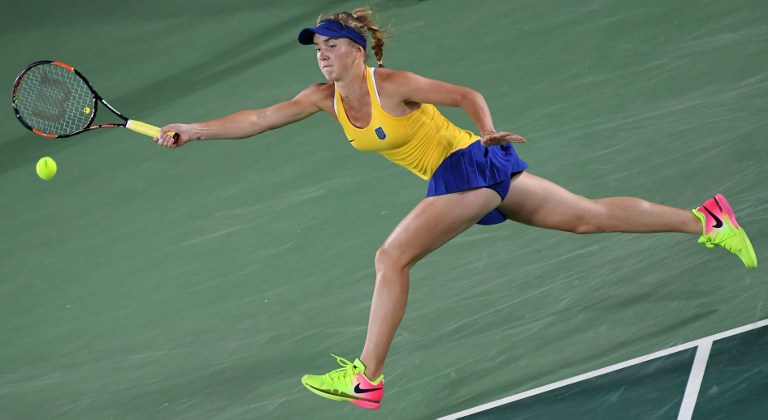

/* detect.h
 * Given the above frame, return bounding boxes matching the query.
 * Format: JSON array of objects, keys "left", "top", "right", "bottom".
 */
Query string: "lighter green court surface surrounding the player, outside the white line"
[{"left": 0, "top": 0, "right": 768, "bottom": 419}]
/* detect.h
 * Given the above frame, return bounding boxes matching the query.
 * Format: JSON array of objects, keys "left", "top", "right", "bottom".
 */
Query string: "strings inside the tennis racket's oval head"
[{"left": 14, "top": 64, "right": 95, "bottom": 135}]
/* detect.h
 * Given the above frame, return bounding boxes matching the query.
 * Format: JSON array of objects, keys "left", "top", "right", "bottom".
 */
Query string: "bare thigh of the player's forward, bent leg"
[{"left": 377, "top": 188, "right": 501, "bottom": 266}]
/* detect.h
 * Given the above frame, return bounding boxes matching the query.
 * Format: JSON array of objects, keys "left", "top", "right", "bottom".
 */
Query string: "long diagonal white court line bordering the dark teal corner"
[{"left": 438, "top": 319, "right": 768, "bottom": 420}]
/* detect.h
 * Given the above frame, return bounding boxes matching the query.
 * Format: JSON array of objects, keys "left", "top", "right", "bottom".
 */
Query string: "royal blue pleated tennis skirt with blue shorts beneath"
[{"left": 427, "top": 140, "right": 528, "bottom": 225}]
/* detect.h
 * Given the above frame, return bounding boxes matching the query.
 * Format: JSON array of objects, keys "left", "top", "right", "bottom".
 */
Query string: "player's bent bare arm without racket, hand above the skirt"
[{"left": 387, "top": 70, "right": 525, "bottom": 146}]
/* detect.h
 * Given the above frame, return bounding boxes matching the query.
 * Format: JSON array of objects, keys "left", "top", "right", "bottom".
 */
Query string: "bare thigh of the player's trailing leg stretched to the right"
[{"left": 499, "top": 172, "right": 600, "bottom": 232}]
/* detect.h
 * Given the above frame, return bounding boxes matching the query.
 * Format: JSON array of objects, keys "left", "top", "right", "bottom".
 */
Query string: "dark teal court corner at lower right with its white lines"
[{"left": 440, "top": 320, "right": 768, "bottom": 420}]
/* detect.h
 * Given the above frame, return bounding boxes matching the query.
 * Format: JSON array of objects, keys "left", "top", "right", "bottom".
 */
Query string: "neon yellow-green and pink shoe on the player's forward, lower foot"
[{"left": 301, "top": 354, "right": 384, "bottom": 410}]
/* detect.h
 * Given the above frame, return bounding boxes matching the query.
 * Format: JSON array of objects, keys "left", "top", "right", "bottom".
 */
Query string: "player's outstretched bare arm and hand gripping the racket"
[{"left": 154, "top": 83, "right": 328, "bottom": 147}]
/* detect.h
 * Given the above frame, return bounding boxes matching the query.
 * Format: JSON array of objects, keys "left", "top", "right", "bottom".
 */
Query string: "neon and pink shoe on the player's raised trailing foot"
[{"left": 691, "top": 194, "right": 757, "bottom": 268}]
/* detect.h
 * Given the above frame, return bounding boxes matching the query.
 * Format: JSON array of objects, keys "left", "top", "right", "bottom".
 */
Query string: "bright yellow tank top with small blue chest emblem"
[{"left": 333, "top": 67, "right": 480, "bottom": 180}]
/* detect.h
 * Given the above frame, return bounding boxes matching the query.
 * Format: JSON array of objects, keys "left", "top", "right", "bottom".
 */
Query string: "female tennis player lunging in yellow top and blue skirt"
[{"left": 155, "top": 8, "right": 757, "bottom": 409}]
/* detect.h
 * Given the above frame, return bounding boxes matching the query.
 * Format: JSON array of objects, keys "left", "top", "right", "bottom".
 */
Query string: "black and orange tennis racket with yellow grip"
[{"left": 12, "top": 60, "right": 176, "bottom": 138}]
